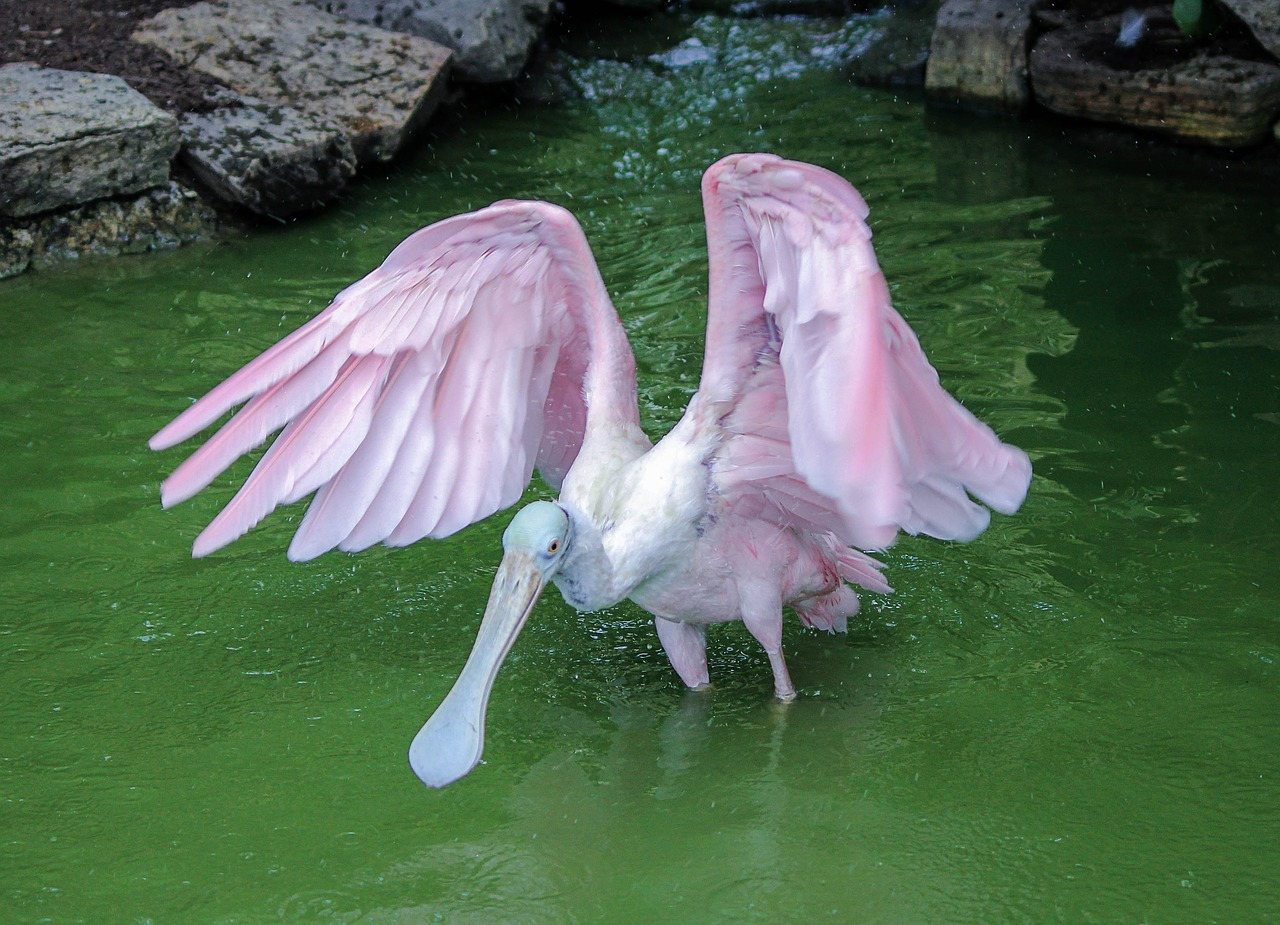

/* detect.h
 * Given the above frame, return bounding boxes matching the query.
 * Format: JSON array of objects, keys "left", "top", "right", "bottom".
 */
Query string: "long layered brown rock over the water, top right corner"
[{"left": 1030, "top": 17, "right": 1280, "bottom": 147}]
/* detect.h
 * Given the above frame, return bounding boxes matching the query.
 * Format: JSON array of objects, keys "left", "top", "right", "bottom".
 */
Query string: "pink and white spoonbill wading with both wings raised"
[{"left": 150, "top": 154, "right": 1032, "bottom": 787}]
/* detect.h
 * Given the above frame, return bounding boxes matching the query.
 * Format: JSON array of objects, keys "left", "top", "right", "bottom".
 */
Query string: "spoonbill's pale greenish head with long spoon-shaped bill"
[{"left": 408, "top": 502, "right": 573, "bottom": 787}]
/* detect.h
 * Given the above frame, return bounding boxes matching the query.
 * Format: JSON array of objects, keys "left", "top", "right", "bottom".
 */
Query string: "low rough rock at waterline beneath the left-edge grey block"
[{"left": 0, "top": 182, "right": 218, "bottom": 279}]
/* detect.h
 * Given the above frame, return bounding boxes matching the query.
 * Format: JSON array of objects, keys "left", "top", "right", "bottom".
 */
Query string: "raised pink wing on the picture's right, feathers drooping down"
[{"left": 700, "top": 155, "right": 1030, "bottom": 549}]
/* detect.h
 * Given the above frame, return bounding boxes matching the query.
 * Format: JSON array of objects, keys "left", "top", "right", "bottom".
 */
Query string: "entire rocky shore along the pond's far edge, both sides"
[{"left": 0, "top": 0, "right": 1280, "bottom": 279}]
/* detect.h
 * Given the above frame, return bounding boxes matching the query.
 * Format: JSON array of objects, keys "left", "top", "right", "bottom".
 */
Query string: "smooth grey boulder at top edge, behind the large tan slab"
[{"left": 311, "top": 0, "right": 552, "bottom": 83}]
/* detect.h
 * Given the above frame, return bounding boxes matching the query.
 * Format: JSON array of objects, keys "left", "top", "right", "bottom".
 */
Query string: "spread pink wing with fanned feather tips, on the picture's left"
[{"left": 151, "top": 201, "right": 637, "bottom": 559}]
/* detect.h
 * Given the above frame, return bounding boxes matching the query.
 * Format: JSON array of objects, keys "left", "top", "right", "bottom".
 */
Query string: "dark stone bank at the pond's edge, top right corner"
[{"left": 925, "top": 0, "right": 1280, "bottom": 148}]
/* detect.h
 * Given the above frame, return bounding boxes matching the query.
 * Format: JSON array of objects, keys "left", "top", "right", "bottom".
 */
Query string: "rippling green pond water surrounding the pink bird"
[{"left": 0, "top": 9, "right": 1280, "bottom": 924}]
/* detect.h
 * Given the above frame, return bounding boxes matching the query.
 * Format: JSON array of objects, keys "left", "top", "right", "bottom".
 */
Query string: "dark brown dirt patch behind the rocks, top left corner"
[{"left": 0, "top": 0, "right": 220, "bottom": 114}]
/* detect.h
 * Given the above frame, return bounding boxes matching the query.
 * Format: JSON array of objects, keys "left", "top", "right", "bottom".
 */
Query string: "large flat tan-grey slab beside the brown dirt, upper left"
[{"left": 133, "top": 0, "right": 449, "bottom": 162}]
